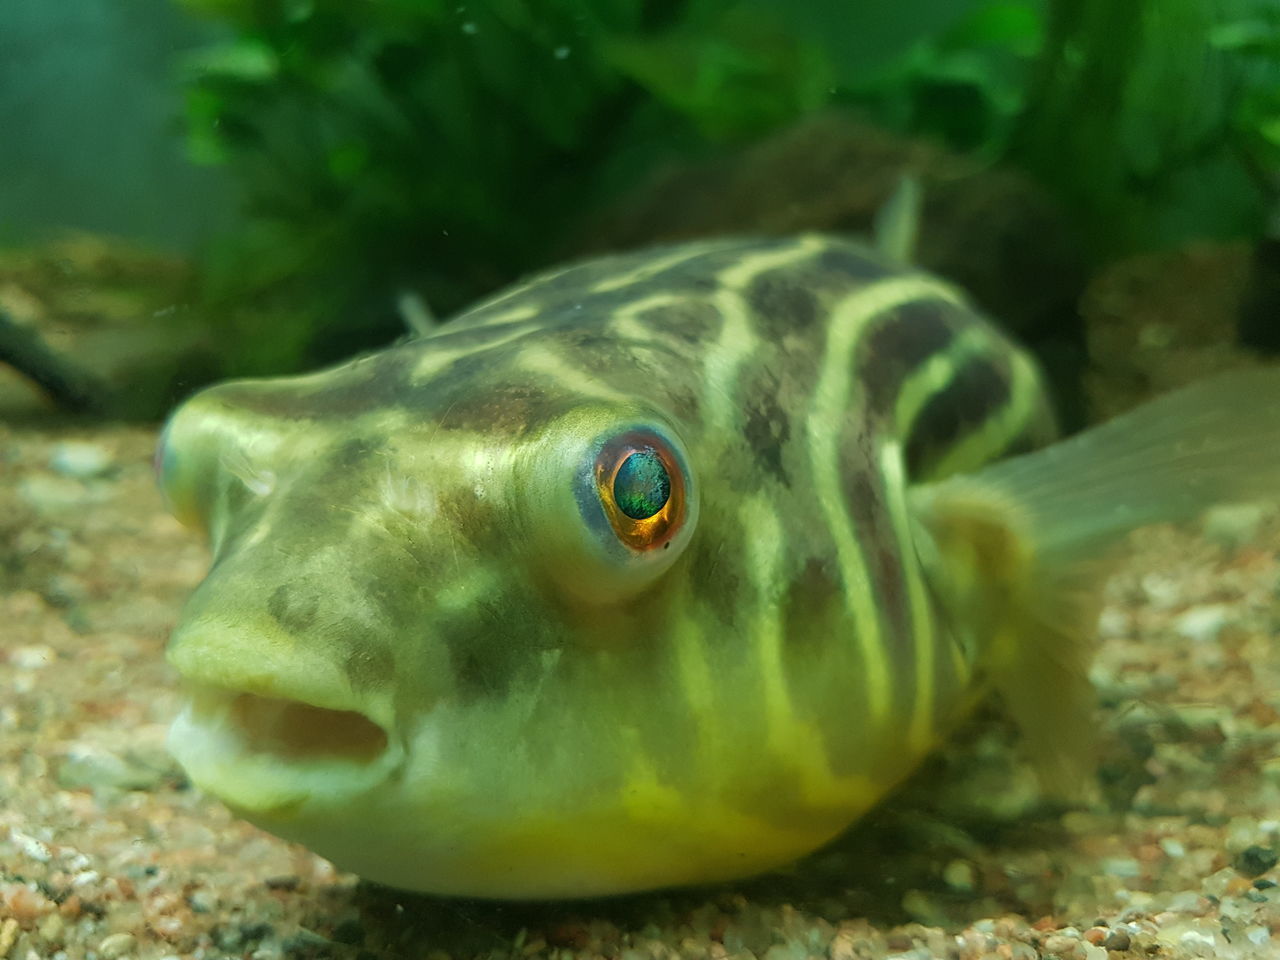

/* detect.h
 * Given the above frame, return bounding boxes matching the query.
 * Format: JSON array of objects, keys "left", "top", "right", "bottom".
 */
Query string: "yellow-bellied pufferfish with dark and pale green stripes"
[{"left": 157, "top": 236, "right": 1280, "bottom": 899}]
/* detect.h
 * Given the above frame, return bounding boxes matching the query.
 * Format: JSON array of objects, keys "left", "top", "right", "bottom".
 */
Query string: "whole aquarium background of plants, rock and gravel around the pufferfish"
[{"left": 0, "top": 0, "right": 1280, "bottom": 960}]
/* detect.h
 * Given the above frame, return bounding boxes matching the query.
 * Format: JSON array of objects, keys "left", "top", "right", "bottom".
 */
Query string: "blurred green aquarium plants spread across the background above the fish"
[{"left": 178, "top": 0, "right": 1280, "bottom": 372}]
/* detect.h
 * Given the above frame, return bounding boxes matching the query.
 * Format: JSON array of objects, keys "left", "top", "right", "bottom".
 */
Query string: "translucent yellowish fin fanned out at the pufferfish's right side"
[{"left": 913, "top": 369, "right": 1280, "bottom": 794}]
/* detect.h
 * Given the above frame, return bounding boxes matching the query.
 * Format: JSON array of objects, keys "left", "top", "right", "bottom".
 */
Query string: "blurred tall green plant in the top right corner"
[{"left": 1010, "top": 0, "right": 1280, "bottom": 252}]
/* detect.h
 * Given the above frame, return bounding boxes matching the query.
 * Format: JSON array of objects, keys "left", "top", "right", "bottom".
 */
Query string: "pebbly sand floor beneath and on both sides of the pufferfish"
[{"left": 0, "top": 424, "right": 1280, "bottom": 960}]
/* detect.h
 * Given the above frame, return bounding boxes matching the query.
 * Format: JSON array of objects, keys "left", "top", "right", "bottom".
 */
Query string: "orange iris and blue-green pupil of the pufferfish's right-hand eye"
[{"left": 595, "top": 430, "right": 685, "bottom": 553}]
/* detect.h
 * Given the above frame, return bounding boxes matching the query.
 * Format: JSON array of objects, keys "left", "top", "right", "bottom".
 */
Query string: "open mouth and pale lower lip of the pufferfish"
[{"left": 169, "top": 682, "right": 403, "bottom": 819}]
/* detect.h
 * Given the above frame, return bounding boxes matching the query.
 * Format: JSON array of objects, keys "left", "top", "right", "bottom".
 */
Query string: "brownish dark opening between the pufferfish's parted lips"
[{"left": 230, "top": 694, "right": 388, "bottom": 763}]
